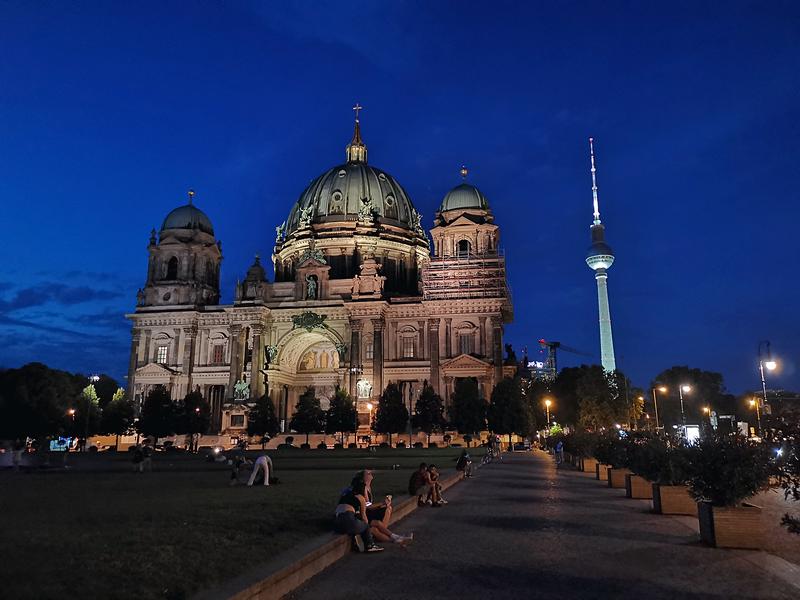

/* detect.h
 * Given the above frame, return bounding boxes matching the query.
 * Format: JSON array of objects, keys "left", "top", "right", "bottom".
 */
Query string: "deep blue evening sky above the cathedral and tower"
[{"left": 0, "top": 0, "right": 800, "bottom": 392}]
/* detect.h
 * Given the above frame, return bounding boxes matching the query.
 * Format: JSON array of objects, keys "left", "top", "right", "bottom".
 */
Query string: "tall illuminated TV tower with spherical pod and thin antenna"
[{"left": 586, "top": 138, "right": 617, "bottom": 373}]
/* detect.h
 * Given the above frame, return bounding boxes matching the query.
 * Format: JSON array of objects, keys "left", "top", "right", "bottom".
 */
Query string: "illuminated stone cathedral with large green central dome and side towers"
[{"left": 127, "top": 112, "right": 513, "bottom": 435}]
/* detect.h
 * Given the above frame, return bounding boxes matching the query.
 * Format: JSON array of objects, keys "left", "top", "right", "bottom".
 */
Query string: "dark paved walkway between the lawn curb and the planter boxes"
[{"left": 292, "top": 453, "right": 800, "bottom": 600}]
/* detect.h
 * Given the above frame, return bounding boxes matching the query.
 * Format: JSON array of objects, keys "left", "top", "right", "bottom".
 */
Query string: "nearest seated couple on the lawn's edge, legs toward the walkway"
[{"left": 334, "top": 471, "right": 414, "bottom": 552}]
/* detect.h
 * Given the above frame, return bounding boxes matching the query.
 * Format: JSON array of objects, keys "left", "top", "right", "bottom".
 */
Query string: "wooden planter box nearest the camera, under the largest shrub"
[{"left": 697, "top": 502, "right": 764, "bottom": 550}]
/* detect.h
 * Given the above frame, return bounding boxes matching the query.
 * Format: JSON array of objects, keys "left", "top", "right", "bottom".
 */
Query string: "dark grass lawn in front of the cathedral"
[{"left": 0, "top": 448, "right": 482, "bottom": 599}]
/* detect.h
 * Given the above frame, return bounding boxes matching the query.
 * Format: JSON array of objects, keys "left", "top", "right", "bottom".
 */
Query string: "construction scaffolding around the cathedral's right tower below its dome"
[{"left": 422, "top": 251, "right": 510, "bottom": 300}]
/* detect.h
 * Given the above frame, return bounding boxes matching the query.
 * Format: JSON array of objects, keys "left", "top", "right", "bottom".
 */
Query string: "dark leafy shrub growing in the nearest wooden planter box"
[{"left": 686, "top": 433, "right": 771, "bottom": 506}]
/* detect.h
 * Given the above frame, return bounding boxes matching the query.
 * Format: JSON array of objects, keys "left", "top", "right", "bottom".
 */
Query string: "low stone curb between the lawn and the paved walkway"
[{"left": 193, "top": 473, "right": 462, "bottom": 600}]
